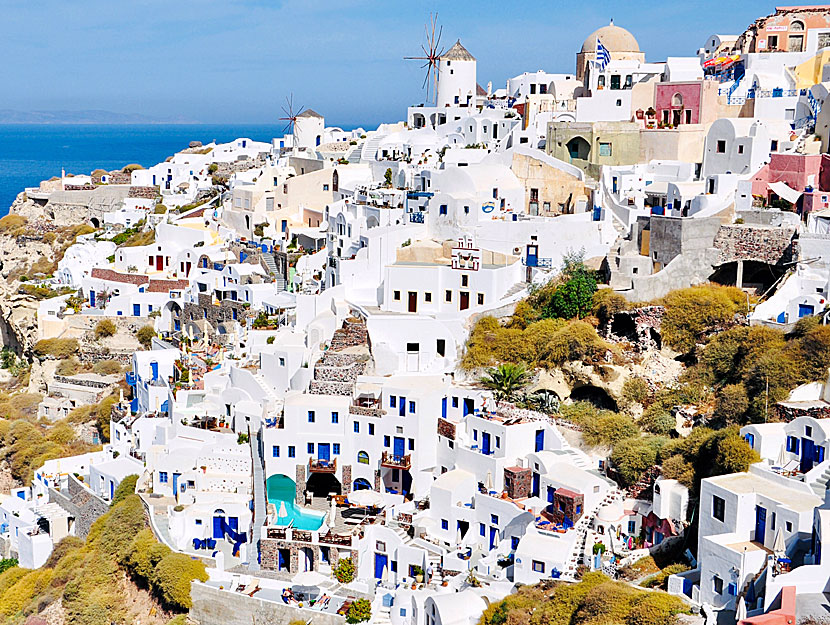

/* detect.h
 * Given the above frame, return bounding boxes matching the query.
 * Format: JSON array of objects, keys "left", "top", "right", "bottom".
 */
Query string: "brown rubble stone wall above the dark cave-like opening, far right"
[{"left": 714, "top": 224, "right": 798, "bottom": 265}]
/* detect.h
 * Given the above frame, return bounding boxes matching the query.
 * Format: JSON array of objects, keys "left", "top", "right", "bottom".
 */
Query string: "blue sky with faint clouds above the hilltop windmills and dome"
[{"left": 0, "top": 0, "right": 775, "bottom": 126}]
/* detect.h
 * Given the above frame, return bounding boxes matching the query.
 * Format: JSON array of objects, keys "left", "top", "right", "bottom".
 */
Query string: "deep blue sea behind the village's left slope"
[{"left": 0, "top": 124, "right": 364, "bottom": 217}]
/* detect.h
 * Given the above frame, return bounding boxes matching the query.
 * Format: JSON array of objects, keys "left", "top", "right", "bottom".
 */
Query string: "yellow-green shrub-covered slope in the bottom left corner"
[{"left": 0, "top": 478, "right": 207, "bottom": 625}]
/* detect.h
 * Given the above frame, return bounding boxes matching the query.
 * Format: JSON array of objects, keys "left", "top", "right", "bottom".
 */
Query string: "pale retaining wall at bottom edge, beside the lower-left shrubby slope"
[{"left": 188, "top": 582, "right": 346, "bottom": 625}]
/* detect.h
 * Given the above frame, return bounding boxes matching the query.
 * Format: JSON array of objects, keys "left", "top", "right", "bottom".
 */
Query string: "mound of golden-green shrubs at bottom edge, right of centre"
[{"left": 479, "top": 572, "right": 687, "bottom": 625}]
